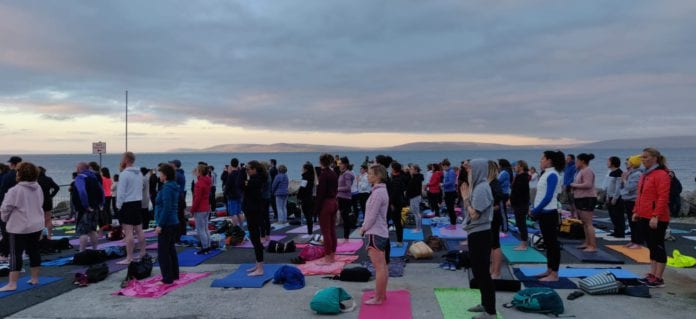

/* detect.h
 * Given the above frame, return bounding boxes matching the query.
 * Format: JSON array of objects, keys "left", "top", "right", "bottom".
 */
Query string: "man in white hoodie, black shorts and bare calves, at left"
[{"left": 116, "top": 152, "right": 146, "bottom": 265}]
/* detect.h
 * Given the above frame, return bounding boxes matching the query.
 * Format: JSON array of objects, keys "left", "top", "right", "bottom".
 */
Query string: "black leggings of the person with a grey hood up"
[{"left": 468, "top": 230, "right": 496, "bottom": 314}]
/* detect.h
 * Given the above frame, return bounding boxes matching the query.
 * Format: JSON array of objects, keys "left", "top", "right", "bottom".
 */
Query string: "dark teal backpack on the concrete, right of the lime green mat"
[{"left": 504, "top": 287, "right": 565, "bottom": 315}]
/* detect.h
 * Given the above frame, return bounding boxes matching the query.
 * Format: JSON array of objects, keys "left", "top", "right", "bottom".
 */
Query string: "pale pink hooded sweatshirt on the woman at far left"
[{"left": 0, "top": 182, "right": 45, "bottom": 234}]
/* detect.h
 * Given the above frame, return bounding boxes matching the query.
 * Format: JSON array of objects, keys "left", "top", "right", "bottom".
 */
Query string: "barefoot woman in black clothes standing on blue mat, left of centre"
[{"left": 242, "top": 161, "right": 270, "bottom": 277}]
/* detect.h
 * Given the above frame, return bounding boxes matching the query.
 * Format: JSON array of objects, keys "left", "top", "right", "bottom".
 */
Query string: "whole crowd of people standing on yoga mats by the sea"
[{"left": 0, "top": 148, "right": 681, "bottom": 318}]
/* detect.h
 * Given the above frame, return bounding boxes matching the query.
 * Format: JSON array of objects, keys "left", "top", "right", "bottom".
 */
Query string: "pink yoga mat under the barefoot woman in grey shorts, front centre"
[{"left": 358, "top": 290, "right": 413, "bottom": 319}]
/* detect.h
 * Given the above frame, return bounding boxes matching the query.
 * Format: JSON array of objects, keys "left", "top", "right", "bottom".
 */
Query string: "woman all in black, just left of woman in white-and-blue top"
[{"left": 510, "top": 160, "right": 530, "bottom": 250}]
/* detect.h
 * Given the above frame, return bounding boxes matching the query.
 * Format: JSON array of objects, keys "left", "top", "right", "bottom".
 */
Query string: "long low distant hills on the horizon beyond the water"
[{"left": 170, "top": 136, "right": 696, "bottom": 153}]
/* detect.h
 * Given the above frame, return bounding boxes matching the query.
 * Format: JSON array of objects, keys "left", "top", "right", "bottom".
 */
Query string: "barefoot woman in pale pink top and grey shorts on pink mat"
[{"left": 360, "top": 164, "right": 391, "bottom": 305}]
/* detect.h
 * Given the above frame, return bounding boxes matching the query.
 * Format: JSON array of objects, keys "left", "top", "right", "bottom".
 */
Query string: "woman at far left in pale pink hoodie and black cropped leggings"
[{"left": 0, "top": 162, "right": 45, "bottom": 291}]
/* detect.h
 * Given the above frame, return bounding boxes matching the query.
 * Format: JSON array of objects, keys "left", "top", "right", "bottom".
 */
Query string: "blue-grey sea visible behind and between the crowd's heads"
[{"left": 0, "top": 149, "right": 696, "bottom": 202}]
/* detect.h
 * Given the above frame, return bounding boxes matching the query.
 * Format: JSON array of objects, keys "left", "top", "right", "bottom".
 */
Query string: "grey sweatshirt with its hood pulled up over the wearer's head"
[{"left": 464, "top": 159, "right": 493, "bottom": 234}]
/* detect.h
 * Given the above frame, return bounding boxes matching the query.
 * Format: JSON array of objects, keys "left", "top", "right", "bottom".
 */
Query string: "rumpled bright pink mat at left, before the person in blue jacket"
[{"left": 112, "top": 272, "right": 210, "bottom": 298}]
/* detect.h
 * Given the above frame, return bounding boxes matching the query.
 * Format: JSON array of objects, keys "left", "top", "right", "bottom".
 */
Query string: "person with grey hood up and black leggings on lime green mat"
[{"left": 459, "top": 159, "right": 496, "bottom": 318}]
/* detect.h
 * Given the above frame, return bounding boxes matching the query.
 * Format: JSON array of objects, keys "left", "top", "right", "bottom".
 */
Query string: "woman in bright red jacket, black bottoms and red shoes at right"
[{"left": 633, "top": 148, "right": 670, "bottom": 288}]
